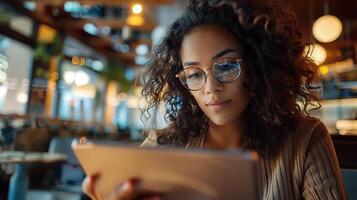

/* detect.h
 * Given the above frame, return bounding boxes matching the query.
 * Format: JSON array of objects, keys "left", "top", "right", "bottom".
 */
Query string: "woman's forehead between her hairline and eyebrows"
[{"left": 180, "top": 25, "right": 243, "bottom": 62}]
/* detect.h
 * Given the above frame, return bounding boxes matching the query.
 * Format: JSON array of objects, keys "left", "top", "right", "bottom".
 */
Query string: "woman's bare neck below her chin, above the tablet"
[{"left": 205, "top": 119, "right": 244, "bottom": 149}]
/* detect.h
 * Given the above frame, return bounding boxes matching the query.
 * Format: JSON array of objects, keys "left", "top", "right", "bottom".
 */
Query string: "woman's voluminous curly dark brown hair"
[{"left": 142, "top": 0, "right": 320, "bottom": 157}]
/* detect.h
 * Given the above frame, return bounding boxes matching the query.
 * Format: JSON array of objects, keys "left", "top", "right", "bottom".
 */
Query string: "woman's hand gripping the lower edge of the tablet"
[{"left": 82, "top": 175, "right": 161, "bottom": 200}]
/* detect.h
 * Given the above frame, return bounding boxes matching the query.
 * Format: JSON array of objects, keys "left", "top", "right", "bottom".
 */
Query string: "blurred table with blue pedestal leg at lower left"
[{"left": 0, "top": 151, "right": 67, "bottom": 200}]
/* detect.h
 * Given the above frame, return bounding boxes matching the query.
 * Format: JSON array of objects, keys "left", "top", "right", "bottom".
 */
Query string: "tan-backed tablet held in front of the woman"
[{"left": 72, "top": 139, "right": 261, "bottom": 200}]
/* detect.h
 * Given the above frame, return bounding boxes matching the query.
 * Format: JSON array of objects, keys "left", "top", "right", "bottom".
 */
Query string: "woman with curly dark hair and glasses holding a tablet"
[{"left": 84, "top": 0, "right": 347, "bottom": 199}]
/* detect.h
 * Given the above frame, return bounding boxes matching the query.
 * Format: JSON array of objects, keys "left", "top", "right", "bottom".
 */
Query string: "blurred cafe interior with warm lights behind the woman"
[{"left": 0, "top": 0, "right": 357, "bottom": 200}]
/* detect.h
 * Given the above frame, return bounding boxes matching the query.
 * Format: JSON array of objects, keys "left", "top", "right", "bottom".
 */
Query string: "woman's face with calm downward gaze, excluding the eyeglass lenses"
[{"left": 180, "top": 25, "right": 247, "bottom": 125}]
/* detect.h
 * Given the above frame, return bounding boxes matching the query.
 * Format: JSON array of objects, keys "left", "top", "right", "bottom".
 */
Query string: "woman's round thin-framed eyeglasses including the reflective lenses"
[{"left": 176, "top": 57, "right": 242, "bottom": 91}]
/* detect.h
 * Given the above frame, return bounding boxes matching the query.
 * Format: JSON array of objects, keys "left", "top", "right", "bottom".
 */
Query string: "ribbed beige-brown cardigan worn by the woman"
[{"left": 141, "top": 118, "right": 347, "bottom": 200}]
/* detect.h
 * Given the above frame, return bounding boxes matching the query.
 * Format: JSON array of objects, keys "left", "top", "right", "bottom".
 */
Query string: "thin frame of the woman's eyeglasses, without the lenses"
[{"left": 175, "top": 57, "right": 242, "bottom": 91}]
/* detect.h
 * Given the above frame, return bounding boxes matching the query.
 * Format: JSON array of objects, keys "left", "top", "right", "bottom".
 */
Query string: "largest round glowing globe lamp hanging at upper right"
[{"left": 312, "top": 15, "right": 342, "bottom": 43}]
